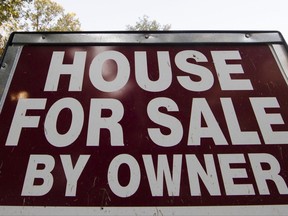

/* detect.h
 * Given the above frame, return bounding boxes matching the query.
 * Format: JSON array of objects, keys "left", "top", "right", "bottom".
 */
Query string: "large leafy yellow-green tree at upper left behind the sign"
[{"left": 0, "top": 0, "right": 81, "bottom": 56}]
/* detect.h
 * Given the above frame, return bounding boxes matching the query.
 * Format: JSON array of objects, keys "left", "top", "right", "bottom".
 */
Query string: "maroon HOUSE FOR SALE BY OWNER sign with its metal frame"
[{"left": 0, "top": 31, "right": 288, "bottom": 215}]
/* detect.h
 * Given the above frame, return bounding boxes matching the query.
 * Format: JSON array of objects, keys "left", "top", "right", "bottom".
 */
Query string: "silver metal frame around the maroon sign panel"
[{"left": 0, "top": 31, "right": 288, "bottom": 215}]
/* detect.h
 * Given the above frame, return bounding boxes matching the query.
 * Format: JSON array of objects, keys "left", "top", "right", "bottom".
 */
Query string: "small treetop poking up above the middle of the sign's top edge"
[{"left": 126, "top": 15, "right": 171, "bottom": 31}]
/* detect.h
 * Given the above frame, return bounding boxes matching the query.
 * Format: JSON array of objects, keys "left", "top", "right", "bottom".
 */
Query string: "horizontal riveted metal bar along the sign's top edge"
[{"left": 11, "top": 31, "right": 283, "bottom": 45}]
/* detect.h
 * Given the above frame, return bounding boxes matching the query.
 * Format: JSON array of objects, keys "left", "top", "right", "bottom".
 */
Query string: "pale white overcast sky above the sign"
[{"left": 54, "top": 0, "right": 288, "bottom": 41}]
